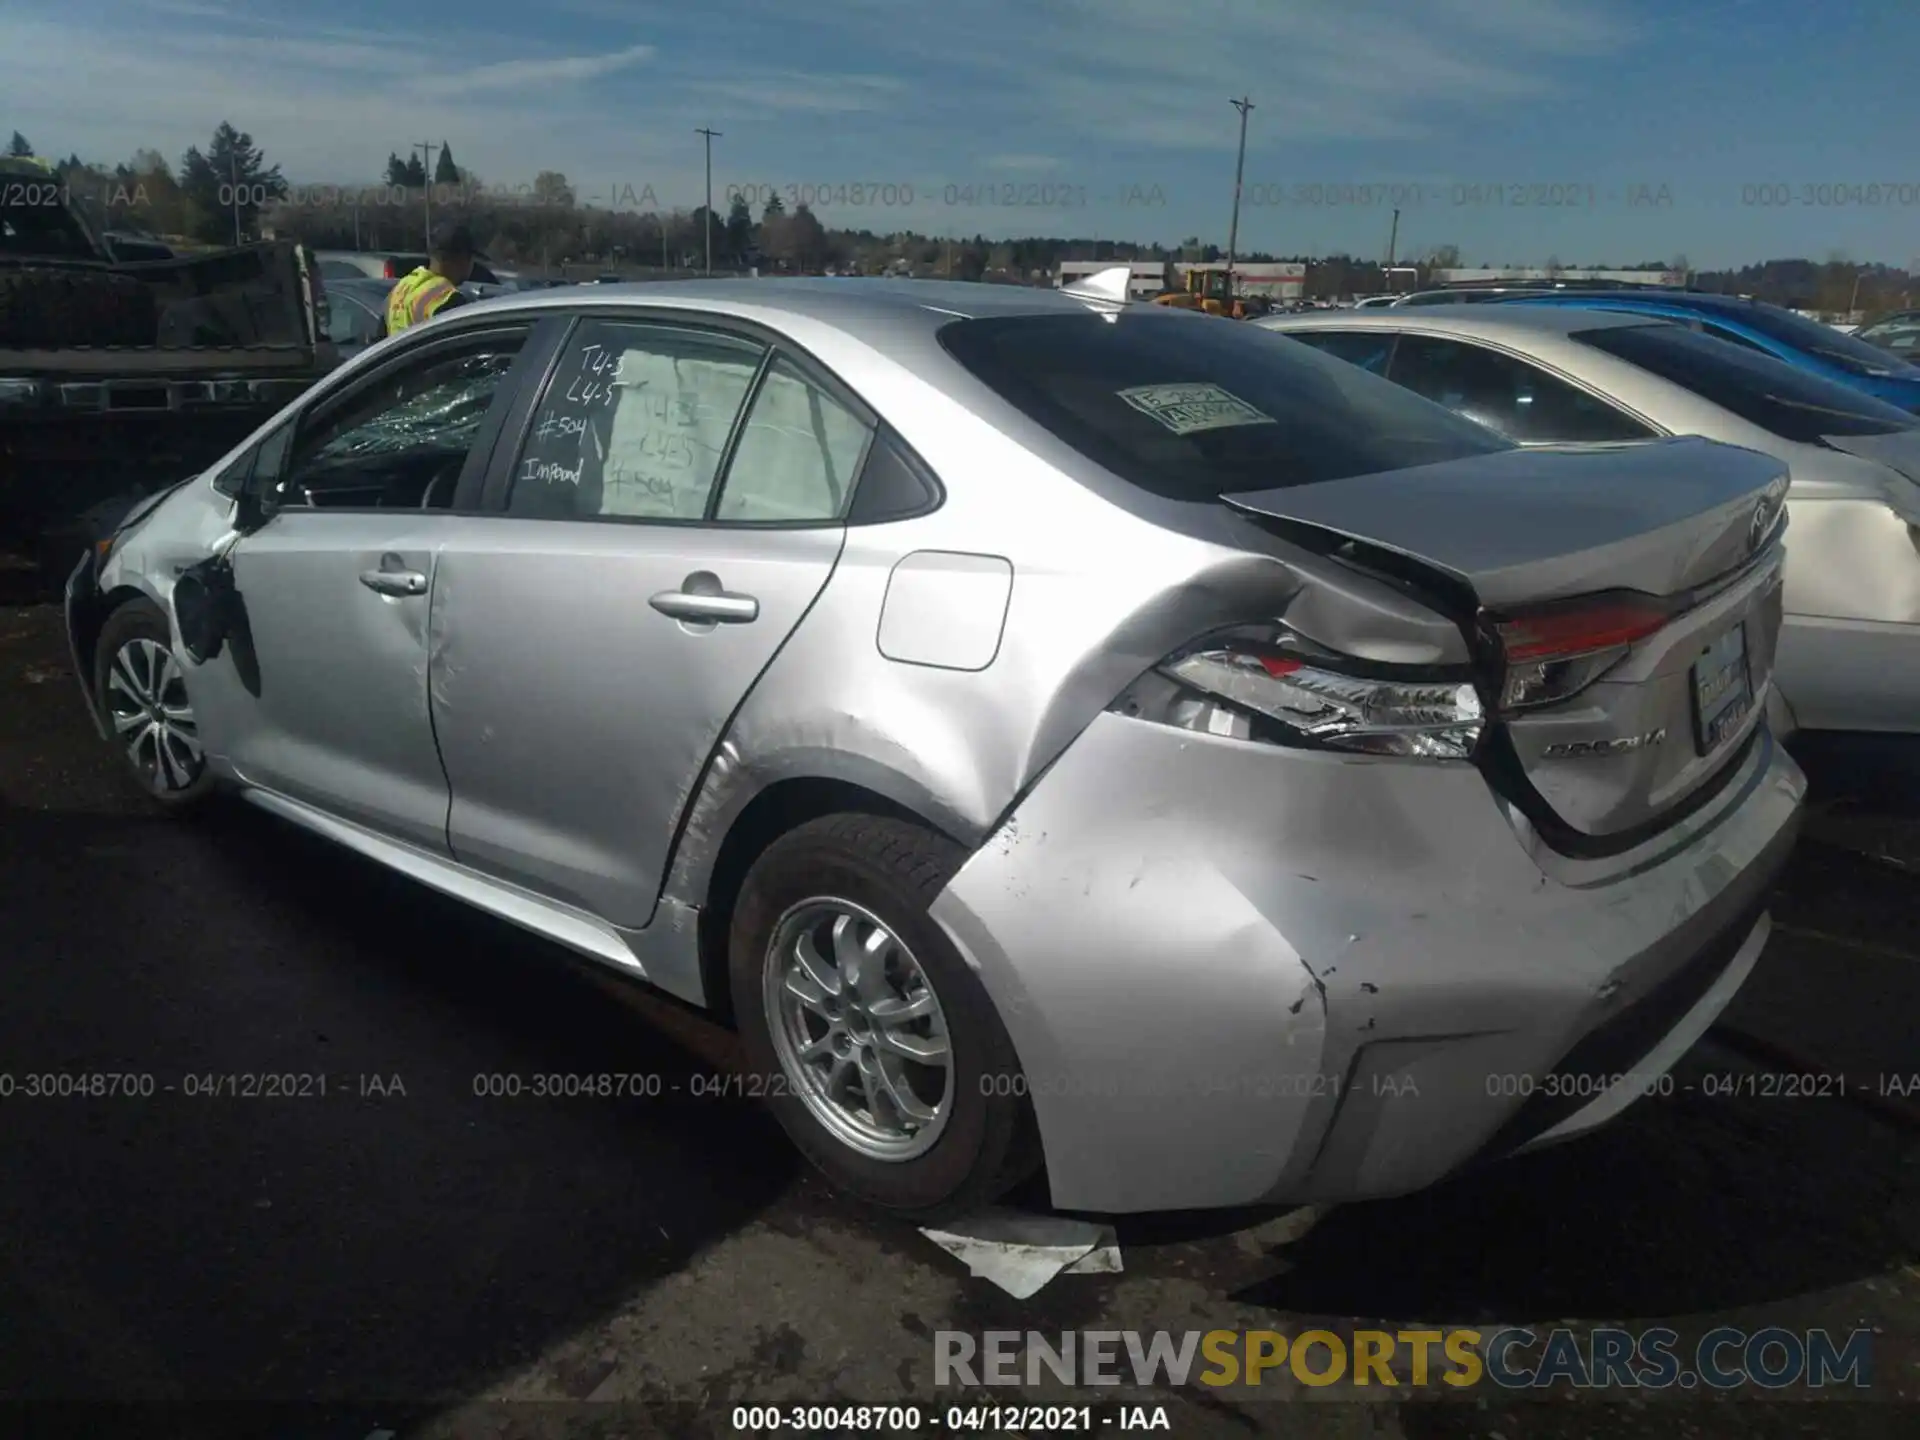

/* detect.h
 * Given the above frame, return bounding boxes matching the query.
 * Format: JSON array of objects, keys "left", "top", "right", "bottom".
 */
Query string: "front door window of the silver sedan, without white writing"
[{"left": 278, "top": 328, "right": 528, "bottom": 507}]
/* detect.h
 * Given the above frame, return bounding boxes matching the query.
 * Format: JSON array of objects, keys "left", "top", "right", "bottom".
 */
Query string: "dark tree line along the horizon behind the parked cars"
[{"left": 8, "top": 121, "right": 1916, "bottom": 311}]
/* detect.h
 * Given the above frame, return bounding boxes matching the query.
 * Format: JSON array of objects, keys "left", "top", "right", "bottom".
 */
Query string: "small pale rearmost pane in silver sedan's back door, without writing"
[{"left": 714, "top": 357, "right": 872, "bottom": 524}]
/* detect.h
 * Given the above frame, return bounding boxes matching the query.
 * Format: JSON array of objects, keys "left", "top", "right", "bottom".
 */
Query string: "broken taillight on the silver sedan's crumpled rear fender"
[{"left": 1116, "top": 628, "right": 1484, "bottom": 760}]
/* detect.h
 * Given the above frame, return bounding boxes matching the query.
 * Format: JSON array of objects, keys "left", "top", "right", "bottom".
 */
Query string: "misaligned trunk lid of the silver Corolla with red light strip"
[{"left": 1223, "top": 438, "right": 1788, "bottom": 852}]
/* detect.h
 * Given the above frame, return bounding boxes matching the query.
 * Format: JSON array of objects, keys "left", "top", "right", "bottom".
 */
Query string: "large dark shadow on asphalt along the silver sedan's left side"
[{"left": 0, "top": 806, "right": 795, "bottom": 1404}]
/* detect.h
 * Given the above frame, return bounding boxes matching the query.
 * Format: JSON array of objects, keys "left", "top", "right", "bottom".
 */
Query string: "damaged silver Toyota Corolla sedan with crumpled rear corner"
[{"left": 69, "top": 280, "right": 1803, "bottom": 1217}]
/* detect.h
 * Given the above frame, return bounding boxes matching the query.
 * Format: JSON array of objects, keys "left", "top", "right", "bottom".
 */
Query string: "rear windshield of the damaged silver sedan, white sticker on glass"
[{"left": 941, "top": 305, "right": 1513, "bottom": 499}]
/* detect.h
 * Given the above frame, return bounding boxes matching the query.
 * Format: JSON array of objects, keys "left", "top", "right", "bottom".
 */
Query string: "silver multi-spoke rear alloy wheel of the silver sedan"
[{"left": 762, "top": 899, "right": 954, "bottom": 1162}]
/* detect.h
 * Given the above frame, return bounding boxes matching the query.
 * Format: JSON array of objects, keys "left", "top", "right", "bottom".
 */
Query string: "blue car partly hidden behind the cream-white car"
[{"left": 1492, "top": 290, "right": 1920, "bottom": 415}]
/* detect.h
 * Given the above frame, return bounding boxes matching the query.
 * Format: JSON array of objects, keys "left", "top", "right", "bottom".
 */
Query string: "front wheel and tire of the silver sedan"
[{"left": 94, "top": 599, "right": 213, "bottom": 812}]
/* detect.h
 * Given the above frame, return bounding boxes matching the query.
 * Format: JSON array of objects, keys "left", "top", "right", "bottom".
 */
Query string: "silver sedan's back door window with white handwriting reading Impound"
[{"left": 507, "top": 321, "right": 766, "bottom": 520}]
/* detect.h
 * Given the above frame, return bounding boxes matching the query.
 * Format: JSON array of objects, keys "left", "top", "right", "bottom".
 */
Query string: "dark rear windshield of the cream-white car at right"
[{"left": 1574, "top": 324, "right": 1916, "bottom": 444}]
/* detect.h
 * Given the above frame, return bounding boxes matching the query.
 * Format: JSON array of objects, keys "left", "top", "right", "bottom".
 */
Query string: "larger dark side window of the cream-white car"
[{"left": 1392, "top": 336, "right": 1653, "bottom": 445}]
